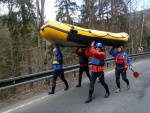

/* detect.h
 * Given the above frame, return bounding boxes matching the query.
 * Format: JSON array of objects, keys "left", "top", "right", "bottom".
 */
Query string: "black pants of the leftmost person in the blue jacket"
[{"left": 52, "top": 70, "right": 68, "bottom": 92}]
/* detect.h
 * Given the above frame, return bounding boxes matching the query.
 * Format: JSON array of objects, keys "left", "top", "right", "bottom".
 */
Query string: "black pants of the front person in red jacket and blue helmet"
[{"left": 89, "top": 72, "right": 109, "bottom": 97}]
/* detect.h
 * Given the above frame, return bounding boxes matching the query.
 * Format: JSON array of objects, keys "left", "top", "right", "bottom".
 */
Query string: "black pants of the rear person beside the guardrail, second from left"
[{"left": 79, "top": 66, "right": 91, "bottom": 85}]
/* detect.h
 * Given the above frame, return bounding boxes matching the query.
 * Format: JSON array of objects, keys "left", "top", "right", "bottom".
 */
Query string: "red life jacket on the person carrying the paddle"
[{"left": 115, "top": 53, "right": 128, "bottom": 70}]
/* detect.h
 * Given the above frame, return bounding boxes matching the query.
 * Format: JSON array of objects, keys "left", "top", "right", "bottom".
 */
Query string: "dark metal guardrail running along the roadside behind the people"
[{"left": 0, "top": 52, "right": 150, "bottom": 90}]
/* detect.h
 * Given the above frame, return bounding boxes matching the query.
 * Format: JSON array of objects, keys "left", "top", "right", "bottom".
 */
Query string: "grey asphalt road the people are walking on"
[{"left": 0, "top": 60, "right": 150, "bottom": 113}]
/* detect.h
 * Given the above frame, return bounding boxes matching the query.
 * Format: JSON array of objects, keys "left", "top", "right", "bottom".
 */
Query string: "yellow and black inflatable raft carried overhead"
[{"left": 40, "top": 21, "right": 129, "bottom": 47}]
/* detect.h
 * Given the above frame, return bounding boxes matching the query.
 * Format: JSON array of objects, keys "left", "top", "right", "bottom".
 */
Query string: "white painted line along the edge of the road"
[{"left": 2, "top": 61, "right": 149, "bottom": 113}]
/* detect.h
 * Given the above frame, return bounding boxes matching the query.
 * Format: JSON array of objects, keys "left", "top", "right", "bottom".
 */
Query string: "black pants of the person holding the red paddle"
[{"left": 115, "top": 68, "right": 129, "bottom": 88}]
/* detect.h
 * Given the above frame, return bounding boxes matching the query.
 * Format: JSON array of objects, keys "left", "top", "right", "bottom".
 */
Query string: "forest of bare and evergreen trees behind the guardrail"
[{"left": 0, "top": 0, "right": 150, "bottom": 80}]
